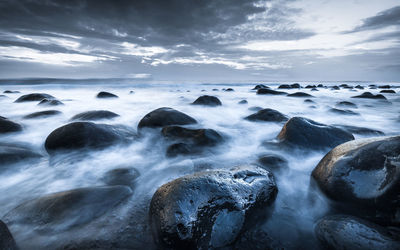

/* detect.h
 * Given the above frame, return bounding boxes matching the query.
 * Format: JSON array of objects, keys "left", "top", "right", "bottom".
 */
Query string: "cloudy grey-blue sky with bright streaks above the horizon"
[{"left": 0, "top": 0, "right": 400, "bottom": 82}]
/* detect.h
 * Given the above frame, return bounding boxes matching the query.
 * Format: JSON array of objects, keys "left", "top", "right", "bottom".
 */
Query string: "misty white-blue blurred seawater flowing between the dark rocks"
[{"left": 0, "top": 81, "right": 400, "bottom": 249}]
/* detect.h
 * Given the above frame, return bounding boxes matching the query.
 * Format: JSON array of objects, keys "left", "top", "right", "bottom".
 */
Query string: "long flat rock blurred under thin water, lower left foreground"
[{"left": 4, "top": 186, "right": 132, "bottom": 231}]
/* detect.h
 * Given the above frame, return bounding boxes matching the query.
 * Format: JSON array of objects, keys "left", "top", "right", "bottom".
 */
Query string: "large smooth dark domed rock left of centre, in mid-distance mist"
[{"left": 45, "top": 122, "right": 134, "bottom": 154}]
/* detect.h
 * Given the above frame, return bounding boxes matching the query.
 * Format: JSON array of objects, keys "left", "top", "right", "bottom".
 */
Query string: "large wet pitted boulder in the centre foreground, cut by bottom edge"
[{"left": 149, "top": 165, "right": 278, "bottom": 249}]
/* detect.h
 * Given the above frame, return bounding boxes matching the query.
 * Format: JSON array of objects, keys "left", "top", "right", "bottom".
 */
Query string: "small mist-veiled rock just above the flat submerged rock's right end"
[{"left": 102, "top": 168, "right": 140, "bottom": 188}]
